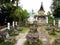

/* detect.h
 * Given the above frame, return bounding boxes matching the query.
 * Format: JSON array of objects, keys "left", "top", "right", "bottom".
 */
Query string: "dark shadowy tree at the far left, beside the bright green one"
[{"left": 0, "top": 0, "right": 15, "bottom": 25}]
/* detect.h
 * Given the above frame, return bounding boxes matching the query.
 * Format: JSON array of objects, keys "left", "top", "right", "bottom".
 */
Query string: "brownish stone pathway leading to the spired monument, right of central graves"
[{"left": 38, "top": 26, "right": 51, "bottom": 45}]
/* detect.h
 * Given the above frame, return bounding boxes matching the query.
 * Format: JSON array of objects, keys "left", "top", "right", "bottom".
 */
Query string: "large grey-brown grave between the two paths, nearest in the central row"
[{"left": 26, "top": 33, "right": 39, "bottom": 44}]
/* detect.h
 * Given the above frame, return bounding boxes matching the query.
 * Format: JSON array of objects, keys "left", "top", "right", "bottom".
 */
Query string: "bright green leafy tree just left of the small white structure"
[{"left": 10, "top": 7, "right": 29, "bottom": 23}]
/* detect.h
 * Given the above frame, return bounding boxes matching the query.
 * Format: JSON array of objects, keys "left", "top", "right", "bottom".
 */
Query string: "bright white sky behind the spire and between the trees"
[{"left": 19, "top": 0, "right": 52, "bottom": 12}]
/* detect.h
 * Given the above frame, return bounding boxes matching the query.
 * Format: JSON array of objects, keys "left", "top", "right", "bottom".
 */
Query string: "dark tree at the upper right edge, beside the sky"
[{"left": 51, "top": 0, "right": 60, "bottom": 18}]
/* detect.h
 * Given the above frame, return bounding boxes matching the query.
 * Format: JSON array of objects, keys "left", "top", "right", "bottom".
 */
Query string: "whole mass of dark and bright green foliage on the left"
[{"left": 0, "top": 0, "right": 29, "bottom": 23}]
